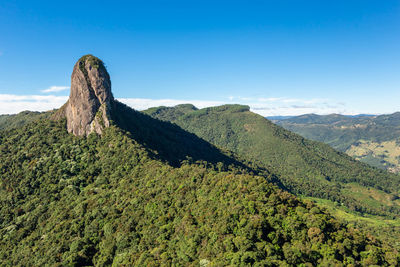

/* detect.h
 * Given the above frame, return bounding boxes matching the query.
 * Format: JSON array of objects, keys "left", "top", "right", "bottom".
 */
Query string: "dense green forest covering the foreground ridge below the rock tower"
[{"left": 0, "top": 116, "right": 399, "bottom": 266}]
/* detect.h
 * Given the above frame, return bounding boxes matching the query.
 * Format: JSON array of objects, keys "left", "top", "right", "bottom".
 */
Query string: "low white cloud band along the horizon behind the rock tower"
[{"left": 0, "top": 94, "right": 366, "bottom": 116}]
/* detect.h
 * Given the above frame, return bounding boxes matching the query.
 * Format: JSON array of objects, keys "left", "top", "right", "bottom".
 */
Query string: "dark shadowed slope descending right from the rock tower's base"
[{"left": 113, "top": 101, "right": 255, "bottom": 171}]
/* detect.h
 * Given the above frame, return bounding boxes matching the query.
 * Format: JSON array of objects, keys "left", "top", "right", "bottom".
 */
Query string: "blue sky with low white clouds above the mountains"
[{"left": 0, "top": 0, "right": 400, "bottom": 116}]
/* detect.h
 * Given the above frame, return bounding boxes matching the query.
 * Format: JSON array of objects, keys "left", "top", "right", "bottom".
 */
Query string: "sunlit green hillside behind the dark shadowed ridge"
[{"left": 144, "top": 105, "right": 400, "bottom": 219}]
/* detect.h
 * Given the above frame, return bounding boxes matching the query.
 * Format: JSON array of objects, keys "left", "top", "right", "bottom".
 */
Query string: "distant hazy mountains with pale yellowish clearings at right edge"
[{"left": 276, "top": 112, "right": 400, "bottom": 173}]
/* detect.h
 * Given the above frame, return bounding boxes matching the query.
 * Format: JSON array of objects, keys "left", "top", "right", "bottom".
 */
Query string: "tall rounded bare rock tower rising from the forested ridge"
[{"left": 65, "top": 55, "right": 114, "bottom": 136}]
